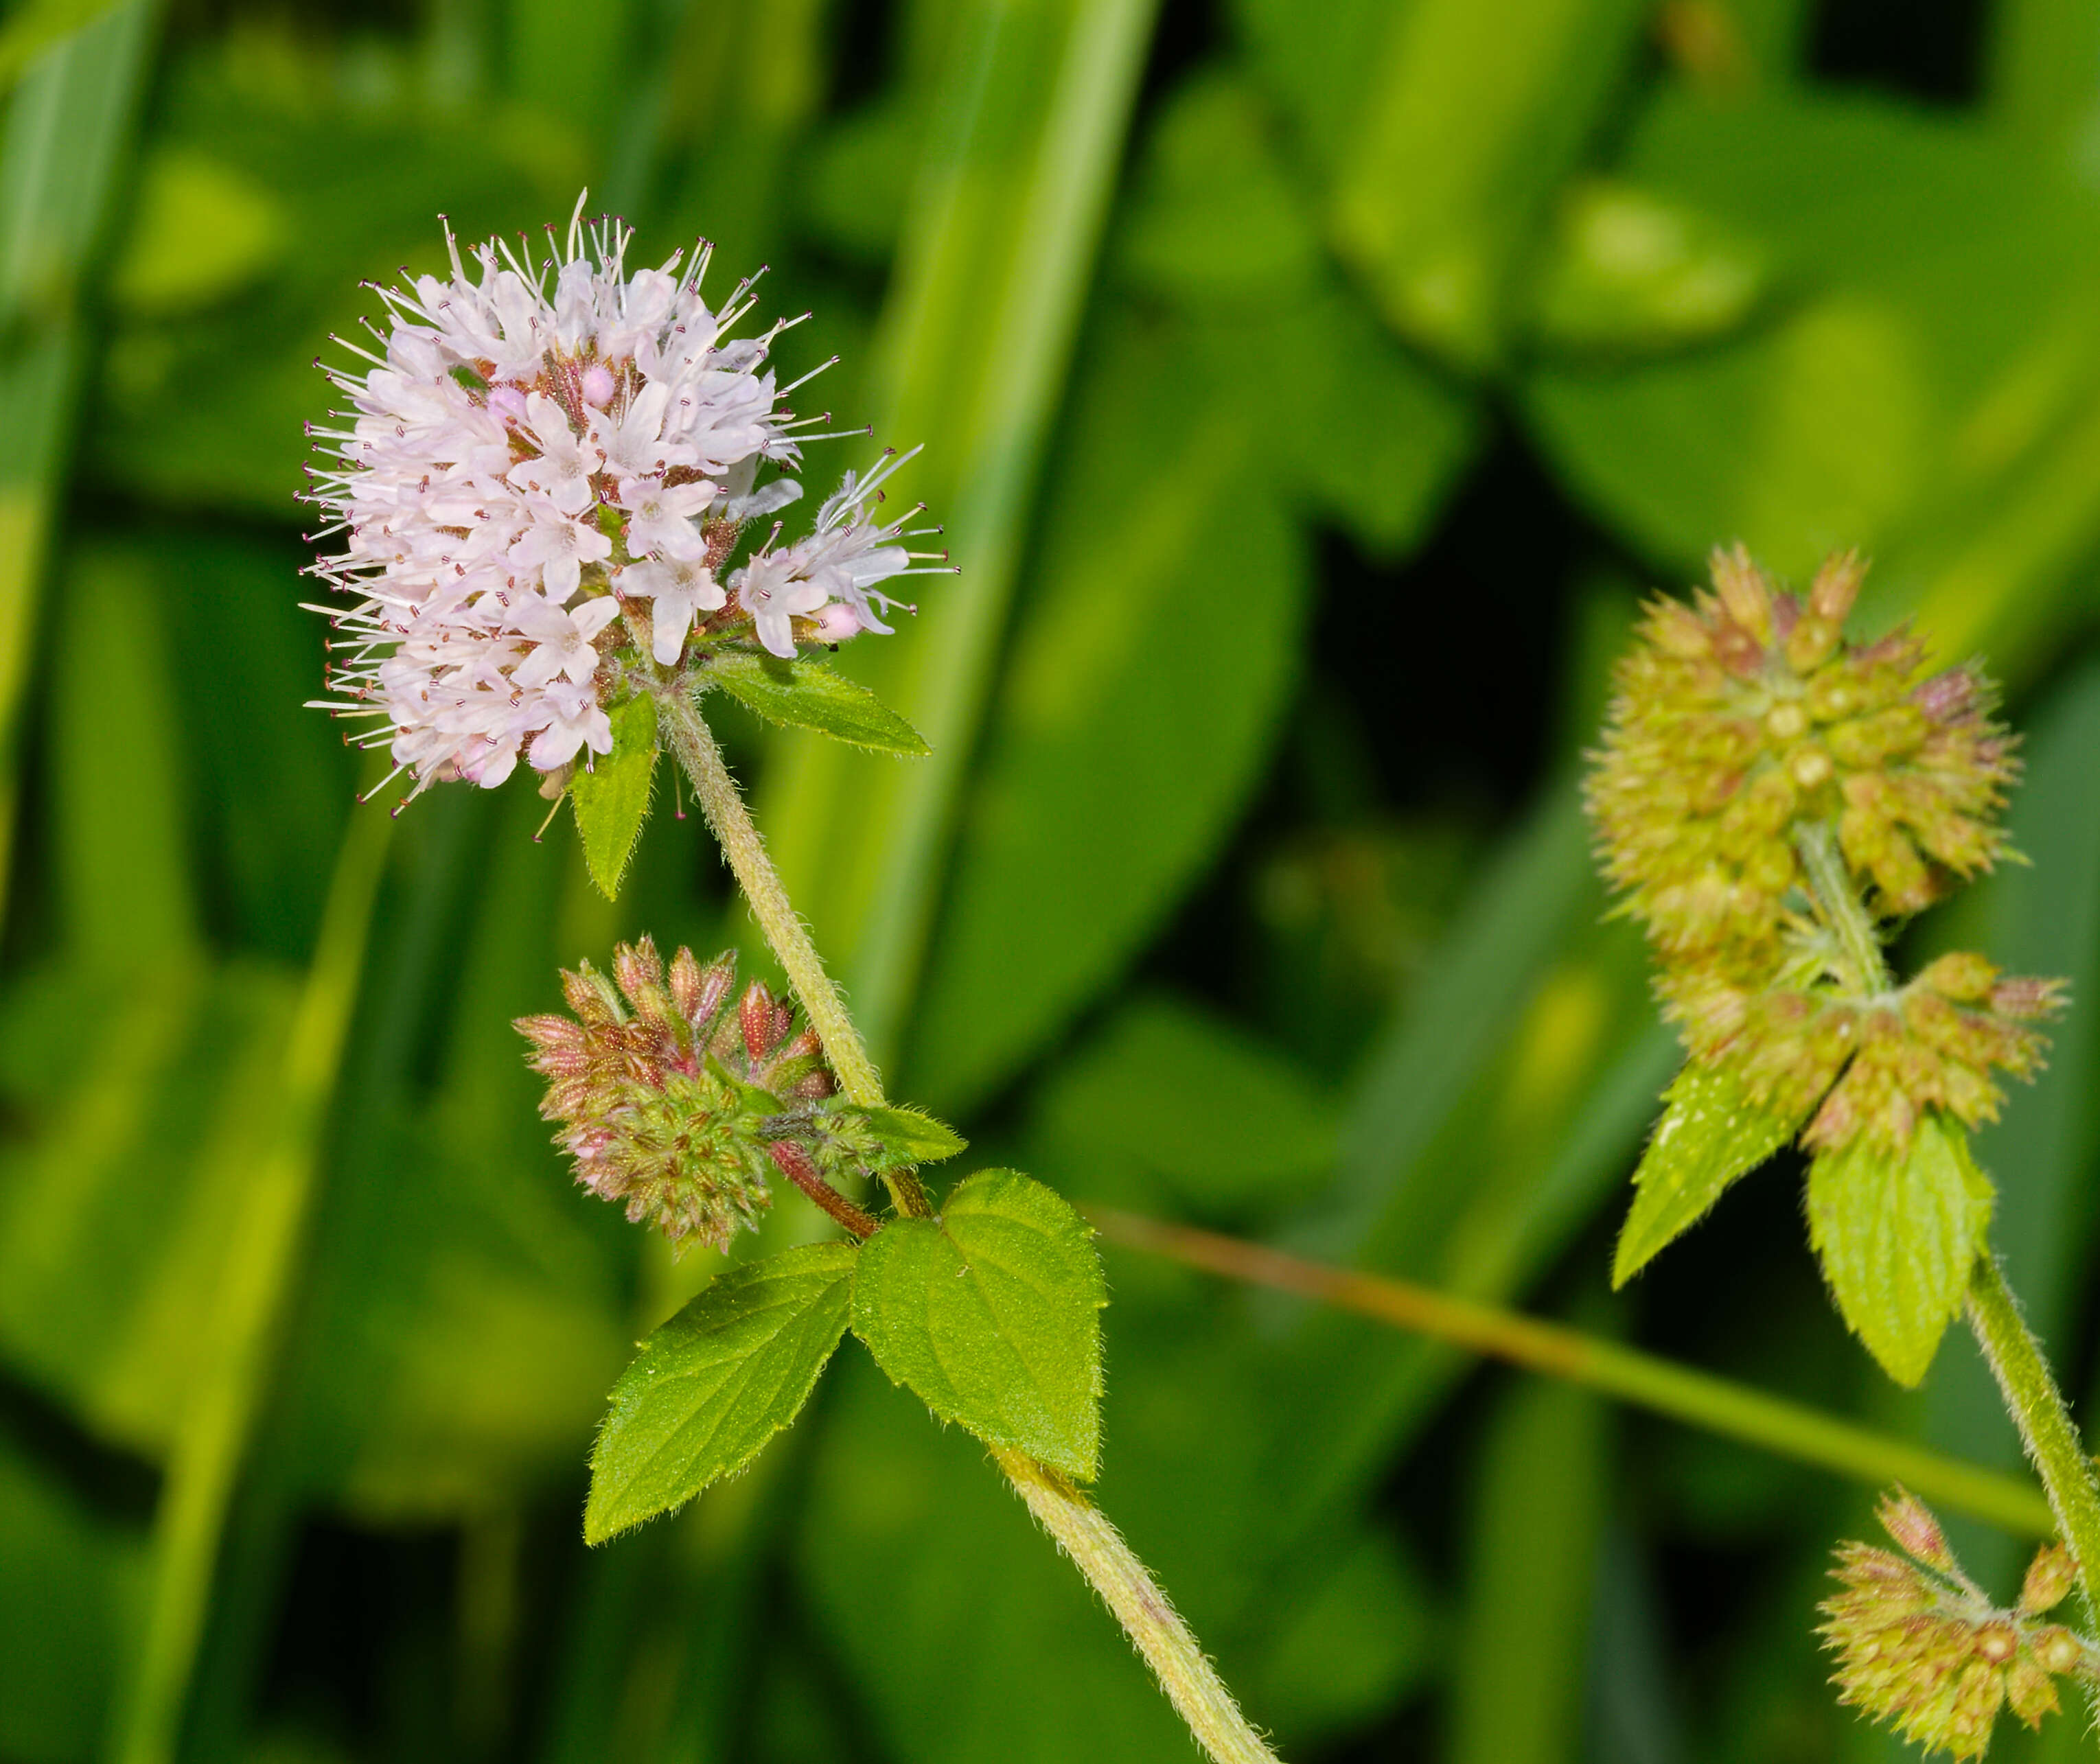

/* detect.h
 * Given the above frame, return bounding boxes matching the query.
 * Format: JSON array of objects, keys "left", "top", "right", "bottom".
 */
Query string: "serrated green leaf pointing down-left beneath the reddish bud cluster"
[{"left": 584, "top": 1243, "right": 855, "bottom": 1544}]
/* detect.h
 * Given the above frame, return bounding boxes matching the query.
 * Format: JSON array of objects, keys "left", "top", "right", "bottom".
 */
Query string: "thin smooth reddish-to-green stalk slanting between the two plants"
[{"left": 1088, "top": 1207, "right": 2050, "bottom": 1537}]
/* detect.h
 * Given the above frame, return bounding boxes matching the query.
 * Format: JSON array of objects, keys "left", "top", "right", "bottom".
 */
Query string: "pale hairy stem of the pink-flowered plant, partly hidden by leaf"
[{"left": 657, "top": 693, "right": 1277, "bottom": 1764}]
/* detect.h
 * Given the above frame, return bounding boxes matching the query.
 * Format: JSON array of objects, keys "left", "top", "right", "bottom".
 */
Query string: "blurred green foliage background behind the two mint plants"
[{"left": 0, "top": 0, "right": 2100, "bottom": 1764}]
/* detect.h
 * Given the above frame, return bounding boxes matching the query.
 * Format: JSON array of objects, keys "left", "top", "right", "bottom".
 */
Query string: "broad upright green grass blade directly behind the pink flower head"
[{"left": 758, "top": 0, "right": 1155, "bottom": 1060}]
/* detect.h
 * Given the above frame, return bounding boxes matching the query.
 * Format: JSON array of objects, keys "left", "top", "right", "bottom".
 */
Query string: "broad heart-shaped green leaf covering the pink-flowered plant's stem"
[{"left": 853, "top": 1170, "right": 1109, "bottom": 1481}]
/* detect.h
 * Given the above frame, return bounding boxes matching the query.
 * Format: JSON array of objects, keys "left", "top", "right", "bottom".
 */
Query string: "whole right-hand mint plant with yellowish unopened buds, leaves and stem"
[{"left": 1588, "top": 546, "right": 2100, "bottom": 1758}]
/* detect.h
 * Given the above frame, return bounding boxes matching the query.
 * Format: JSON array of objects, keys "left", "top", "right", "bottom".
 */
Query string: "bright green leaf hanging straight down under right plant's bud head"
[{"left": 1808, "top": 1113, "right": 1993, "bottom": 1386}]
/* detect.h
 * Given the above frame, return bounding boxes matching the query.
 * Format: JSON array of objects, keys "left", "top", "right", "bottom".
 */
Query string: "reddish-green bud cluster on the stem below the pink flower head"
[{"left": 517, "top": 937, "right": 838, "bottom": 1249}]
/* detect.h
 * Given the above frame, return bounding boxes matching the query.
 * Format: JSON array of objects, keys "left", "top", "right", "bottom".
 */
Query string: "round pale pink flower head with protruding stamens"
[{"left": 309, "top": 202, "right": 930, "bottom": 789}]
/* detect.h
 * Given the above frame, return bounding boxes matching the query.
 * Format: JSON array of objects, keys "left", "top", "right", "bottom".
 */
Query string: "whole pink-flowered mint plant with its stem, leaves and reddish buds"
[{"left": 311, "top": 202, "right": 1273, "bottom": 1764}]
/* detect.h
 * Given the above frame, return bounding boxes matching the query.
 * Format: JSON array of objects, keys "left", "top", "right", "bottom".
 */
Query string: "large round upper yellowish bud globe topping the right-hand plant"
[{"left": 1590, "top": 546, "right": 2016, "bottom": 960}]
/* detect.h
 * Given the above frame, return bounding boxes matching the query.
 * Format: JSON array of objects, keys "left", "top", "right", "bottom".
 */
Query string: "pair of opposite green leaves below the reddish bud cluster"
[{"left": 584, "top": 1170, "right": 1109, "bottom": 1544}]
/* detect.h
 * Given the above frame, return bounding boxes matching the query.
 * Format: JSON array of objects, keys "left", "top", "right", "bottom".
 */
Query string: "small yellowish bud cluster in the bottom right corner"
[{"left": 1819, "top": 1489, "right": 2100, "bottom": 1758}]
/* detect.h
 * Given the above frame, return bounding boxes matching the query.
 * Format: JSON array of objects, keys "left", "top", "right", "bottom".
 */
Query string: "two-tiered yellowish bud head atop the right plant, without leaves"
[{"left": 1588, "top": 546, "right": 2062, "bottom": 1153}]
